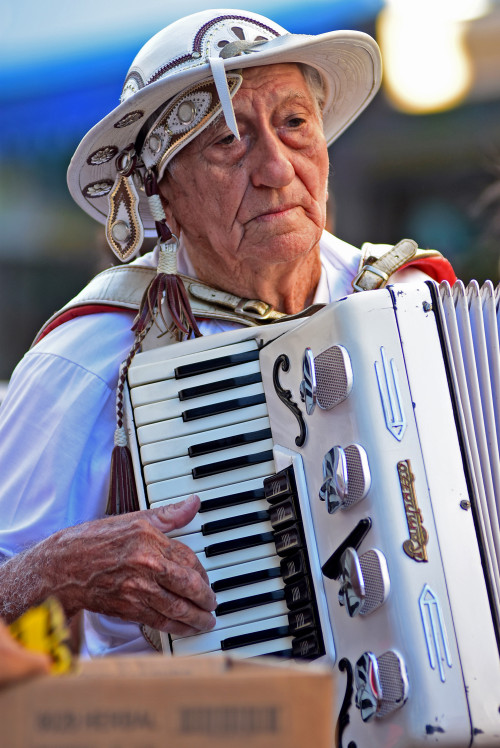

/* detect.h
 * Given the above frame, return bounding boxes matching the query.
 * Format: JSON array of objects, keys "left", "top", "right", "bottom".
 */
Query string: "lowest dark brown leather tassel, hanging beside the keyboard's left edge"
[{"left": 106, "top": 427, "right": 139, "bottom": 514}]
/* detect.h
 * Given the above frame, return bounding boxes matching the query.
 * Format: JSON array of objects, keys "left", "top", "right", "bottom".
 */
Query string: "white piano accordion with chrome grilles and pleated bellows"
[{"left": 124, "top": 282, "right": 500, "bottom": 748}]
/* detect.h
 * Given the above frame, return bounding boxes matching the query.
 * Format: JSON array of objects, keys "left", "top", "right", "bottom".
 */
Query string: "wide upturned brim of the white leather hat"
[{"left": 68, "top": 31, "right": 382, "bottom": 235}]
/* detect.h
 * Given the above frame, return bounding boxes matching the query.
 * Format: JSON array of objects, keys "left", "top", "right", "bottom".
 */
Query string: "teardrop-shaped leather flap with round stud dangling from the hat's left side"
[{"left": 106, "top": 174, "right": 144, "bottom": 262}]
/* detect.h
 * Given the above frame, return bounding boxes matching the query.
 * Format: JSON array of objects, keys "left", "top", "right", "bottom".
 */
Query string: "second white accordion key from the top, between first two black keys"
[{"left": 130, "top": 361, "right": 260, "bottom": 408}]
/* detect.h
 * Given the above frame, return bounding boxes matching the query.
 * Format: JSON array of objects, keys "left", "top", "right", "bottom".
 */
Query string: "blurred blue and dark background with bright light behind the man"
[{"left": 0, "top": 0, "right": 500, "bottom": 382}]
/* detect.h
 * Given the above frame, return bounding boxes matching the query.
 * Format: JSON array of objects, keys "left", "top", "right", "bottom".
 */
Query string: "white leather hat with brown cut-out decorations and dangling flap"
[{"left": 68, "top": 9, "right": 382, "bottom": 260}]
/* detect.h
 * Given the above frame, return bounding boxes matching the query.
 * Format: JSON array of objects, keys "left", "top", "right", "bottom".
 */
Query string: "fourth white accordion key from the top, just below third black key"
[{"left": 137, "top": 403, "right": 267, "bottom": 445}]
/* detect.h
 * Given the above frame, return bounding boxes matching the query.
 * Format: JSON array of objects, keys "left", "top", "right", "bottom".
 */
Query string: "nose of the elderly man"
[{"left": 251, "top": 130, "right": 295, "bottom": 188}]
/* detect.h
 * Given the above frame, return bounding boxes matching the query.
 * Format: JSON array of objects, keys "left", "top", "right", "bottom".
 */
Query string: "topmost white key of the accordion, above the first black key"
[{"left": 128, "top": 340, "right": 257, "bottom": 389}]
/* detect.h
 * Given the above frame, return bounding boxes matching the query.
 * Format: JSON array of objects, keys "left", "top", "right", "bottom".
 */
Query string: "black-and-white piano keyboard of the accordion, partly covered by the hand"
[{"left": 125, "top": 328, "right": 332, "bottom": 659}]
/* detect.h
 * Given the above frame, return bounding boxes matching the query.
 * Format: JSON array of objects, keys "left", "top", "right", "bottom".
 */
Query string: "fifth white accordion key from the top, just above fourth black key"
[{"left": 141, "top": 418, "right": 270, "bottom": 465}]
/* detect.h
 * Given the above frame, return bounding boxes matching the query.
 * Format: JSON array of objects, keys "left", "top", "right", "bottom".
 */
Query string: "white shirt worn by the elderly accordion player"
[{"left": 0, "top": 232, "right": 418, "bottom": 656}]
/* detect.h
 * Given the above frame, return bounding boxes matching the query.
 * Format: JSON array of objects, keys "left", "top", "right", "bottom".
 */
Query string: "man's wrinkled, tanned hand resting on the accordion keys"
[{"left": 0, "top": 496, "right": 216, "bottom": 635}]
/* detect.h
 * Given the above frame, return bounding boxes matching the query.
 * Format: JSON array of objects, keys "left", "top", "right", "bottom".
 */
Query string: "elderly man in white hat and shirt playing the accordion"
[{"left": 0, "top": 10, "right": 453, "bottom": 655}]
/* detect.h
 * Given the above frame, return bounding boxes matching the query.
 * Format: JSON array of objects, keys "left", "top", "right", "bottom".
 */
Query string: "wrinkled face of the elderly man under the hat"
[{"left": 160, "top": 64, "right": 328, "bottom": 280}]
